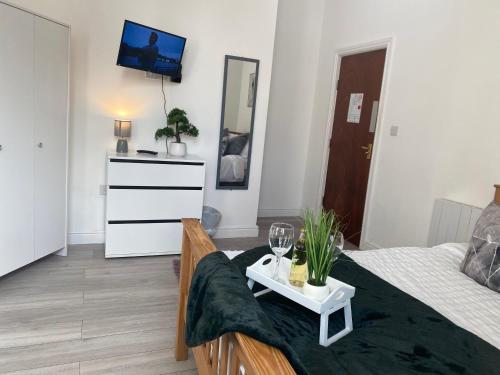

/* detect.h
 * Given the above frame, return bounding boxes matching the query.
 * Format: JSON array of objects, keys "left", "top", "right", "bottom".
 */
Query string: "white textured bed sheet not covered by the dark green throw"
[{"left": 225, "top": 244, "right": 500, "bottom": 349}]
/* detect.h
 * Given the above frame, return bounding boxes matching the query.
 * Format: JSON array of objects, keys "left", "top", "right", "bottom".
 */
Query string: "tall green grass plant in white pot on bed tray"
[{"left": 303, "top": 209, "right": 344, "bottom": 301}]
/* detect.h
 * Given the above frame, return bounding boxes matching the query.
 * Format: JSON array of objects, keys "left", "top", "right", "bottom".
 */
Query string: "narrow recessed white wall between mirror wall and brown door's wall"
[{"left": 259, "top": 0, "right": 325, "bottom": 216}]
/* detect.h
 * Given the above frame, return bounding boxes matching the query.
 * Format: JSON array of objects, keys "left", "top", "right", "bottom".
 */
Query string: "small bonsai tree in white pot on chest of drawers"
[{"left": 155, "top": 108, "right": 199, "bottom": 156}]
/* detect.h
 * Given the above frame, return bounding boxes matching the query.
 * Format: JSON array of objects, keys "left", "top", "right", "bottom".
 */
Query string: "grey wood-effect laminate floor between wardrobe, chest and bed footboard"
[{"left": 0, "top": 245, "right": 197, "bottom": 375}]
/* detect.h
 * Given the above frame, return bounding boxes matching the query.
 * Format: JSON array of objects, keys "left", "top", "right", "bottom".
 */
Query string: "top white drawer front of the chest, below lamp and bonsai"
[{"left": 108, "top": 158, "right": 205, "bottom": 186}]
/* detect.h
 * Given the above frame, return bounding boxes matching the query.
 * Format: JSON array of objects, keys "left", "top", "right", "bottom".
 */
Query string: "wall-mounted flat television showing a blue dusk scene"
[{"left": 116, "top": 20, "right": 186, "bottom": 76}]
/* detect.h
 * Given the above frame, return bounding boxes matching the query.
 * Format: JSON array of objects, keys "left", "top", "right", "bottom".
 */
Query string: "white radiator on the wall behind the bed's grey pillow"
[{"left": 428, "top": 199, "right": 482, "bottom": 247}]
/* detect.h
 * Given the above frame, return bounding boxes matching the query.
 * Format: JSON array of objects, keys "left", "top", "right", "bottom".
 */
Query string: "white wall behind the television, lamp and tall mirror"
[{"left": 7, "top": 0, "right": 277, "bottom": 243}]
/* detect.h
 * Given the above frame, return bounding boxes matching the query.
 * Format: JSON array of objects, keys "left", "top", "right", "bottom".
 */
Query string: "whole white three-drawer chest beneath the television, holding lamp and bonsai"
[{"left": 106, "top": 153, "right": 205, "bottom": 258}]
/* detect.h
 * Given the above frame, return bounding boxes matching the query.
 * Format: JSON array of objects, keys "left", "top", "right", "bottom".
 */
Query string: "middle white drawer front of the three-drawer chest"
[{"left": 107, "top": 187, "right": 203, "bottom": 220}]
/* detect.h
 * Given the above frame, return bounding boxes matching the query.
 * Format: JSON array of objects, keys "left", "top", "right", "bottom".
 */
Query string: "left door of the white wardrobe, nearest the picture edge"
[{"left": 0, "top": 3, "right": 34, "bottom": 275}]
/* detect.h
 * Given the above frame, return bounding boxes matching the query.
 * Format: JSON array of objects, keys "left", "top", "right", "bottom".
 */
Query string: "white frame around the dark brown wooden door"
[{"left": 316, "top": 37, "right": 394, "bottom": 249}]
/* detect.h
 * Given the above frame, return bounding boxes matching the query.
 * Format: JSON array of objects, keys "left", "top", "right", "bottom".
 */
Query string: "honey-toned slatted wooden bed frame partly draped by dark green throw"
[{"left": 175, "top": 185, "right": 500, "bottom": 375}]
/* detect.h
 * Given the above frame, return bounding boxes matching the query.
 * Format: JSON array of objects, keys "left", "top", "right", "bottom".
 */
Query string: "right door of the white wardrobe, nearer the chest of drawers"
[{"left": 34, "top": 16, "right": 69, "bottom": 259}]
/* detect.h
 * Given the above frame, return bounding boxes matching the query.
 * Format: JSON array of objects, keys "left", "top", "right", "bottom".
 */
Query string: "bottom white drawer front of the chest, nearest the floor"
[{"left": 106, "top": 223, "right": 182, "bottom": 257}]
